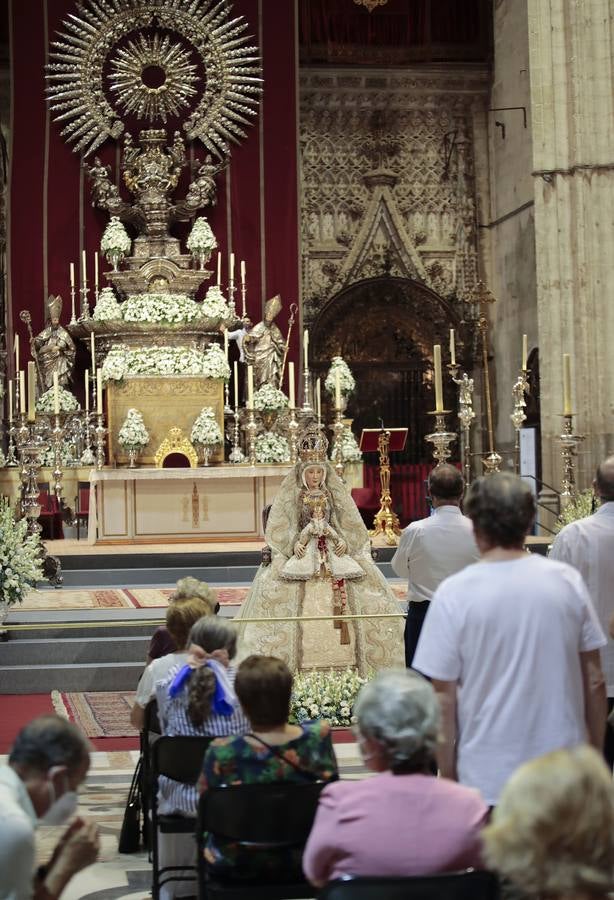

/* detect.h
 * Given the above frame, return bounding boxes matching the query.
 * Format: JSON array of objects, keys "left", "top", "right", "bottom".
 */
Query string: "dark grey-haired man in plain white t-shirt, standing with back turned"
[{"left": 414, "top": 474, "right": 606, "bottom": 806}]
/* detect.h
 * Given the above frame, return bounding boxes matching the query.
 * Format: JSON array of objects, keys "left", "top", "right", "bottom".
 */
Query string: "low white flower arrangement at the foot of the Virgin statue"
[{"left": 290, "top": 669, "right": 369, "bottom": 727}]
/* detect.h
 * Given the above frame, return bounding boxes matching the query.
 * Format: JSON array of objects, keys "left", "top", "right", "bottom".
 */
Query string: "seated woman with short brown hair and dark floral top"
[{"left": 199, "top": 656, "right": 338, "bottom": 881}]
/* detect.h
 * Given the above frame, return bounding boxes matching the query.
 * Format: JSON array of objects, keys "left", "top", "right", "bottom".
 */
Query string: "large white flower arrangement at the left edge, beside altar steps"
[{"left": 0, "top": 498, "right": 43, "bottom": 606}]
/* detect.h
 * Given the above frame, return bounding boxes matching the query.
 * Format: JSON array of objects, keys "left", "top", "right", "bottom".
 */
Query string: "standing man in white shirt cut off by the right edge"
[{"left": 550, "top": 456, "right": 614, "bottom": 769}]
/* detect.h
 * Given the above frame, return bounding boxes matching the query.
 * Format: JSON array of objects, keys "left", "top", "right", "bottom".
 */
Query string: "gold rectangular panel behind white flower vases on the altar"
[{"left": 107, "top": 375, "right": 224, "bottom": 466}]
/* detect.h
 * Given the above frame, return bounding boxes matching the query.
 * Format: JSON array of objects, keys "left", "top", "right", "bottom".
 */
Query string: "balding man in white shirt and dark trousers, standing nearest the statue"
[{"left": 391, "top": 463, "right": 480, "bottom": 668}]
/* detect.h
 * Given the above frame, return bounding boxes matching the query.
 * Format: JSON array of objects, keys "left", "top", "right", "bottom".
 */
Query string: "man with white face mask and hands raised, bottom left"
[{"left": 0, "top": 715, "right": 100, "bottom": 900}]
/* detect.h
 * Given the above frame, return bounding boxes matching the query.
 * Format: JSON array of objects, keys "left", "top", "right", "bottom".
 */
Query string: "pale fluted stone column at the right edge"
[{"left": 528, "top": 0, "right": 614, "bottom": 488}]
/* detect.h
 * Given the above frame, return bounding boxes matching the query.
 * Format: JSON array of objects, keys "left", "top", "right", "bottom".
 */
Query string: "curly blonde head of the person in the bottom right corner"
[{"left": 483, "top": 746, "right": 614, "bottom": 900}]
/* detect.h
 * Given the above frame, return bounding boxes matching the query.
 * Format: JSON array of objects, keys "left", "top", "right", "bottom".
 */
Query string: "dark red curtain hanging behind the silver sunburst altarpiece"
[{"left": 8, "top": 0, "right": 299, "bottom": 367}]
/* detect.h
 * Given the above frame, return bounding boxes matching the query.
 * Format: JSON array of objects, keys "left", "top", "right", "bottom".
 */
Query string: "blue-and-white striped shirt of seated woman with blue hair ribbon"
[{"left": 156, "top": 666, "right": 251, "bottom": 816}]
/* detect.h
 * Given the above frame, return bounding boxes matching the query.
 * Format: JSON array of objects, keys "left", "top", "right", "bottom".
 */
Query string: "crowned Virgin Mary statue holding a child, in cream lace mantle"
[{"left": 236, "top": 430, "right": 405, "bottom": 674}]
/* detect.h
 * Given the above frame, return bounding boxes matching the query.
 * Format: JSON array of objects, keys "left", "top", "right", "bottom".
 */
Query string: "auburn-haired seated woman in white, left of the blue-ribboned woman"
[{"left": 130, "top": 597, "right": 212, "bottom": 731}]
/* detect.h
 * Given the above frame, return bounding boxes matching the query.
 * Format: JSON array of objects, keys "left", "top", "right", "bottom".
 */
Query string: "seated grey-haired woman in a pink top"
[{"left": 303, "top": 670, "right": 488, "bottom": 887}]
